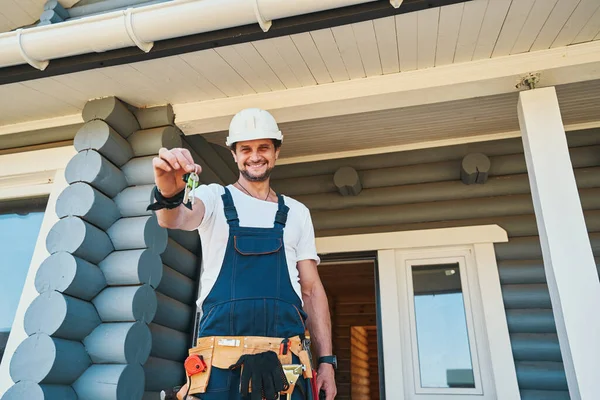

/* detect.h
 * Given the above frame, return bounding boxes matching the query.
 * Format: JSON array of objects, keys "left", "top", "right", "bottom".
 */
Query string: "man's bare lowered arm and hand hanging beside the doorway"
[{"left": 298, "top": 260, "right": 337, "bottom": 400}]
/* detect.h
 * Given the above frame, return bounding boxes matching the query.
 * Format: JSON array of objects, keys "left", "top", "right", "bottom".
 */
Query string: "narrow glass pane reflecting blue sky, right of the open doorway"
[{"left": 412, "top": 263, "right": 475, "bottom": 388}]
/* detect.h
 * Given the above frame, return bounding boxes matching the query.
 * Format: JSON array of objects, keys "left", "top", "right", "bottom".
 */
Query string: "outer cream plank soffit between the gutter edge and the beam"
[{"left": 0, "top": 0, "right": 600, "bottom": 125}]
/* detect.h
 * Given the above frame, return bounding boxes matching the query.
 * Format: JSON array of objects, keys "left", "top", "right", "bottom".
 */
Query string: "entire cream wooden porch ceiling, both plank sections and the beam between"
[{"left": 0, "top": 0, "right": 600, "bottom": 163}]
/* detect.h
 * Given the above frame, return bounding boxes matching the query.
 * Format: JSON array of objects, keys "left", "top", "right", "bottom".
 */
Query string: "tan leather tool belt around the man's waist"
[{"left": 185, "top": 336, "right": 313, "bottom": 394}]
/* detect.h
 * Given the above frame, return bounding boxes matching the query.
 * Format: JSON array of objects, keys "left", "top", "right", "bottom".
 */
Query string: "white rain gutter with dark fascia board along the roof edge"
[{"left": 0, "top": 0, "right": 454, "bottom": 84}]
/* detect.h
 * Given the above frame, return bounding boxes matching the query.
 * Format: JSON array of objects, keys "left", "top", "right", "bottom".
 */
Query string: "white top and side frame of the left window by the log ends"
[{"left": 0, "top": 146, "right": 77, "bottom": 397}]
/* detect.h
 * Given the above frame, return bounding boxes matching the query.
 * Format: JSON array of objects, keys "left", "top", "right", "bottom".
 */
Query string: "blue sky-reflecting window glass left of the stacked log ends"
[{"left": 0, "top": 203, "right": 44, "bottom": 332}]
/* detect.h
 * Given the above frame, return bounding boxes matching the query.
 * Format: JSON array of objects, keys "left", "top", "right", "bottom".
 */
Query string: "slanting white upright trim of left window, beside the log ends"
[{"left": 0, "top": 169, "right": 68, "bottom": 397}]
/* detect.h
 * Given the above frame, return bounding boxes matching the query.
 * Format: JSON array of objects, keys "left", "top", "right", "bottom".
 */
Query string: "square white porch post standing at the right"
[{"left": 518, "top": 87, "right": 600, "bottom": 400}]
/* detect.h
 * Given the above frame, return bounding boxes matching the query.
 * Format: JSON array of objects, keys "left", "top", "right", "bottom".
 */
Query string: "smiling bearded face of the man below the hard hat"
[{"left": 232, "top": 139, "right": 279, "bottom": 182}]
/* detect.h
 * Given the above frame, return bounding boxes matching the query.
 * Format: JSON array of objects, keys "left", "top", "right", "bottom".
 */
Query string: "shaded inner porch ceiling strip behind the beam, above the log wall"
[{"left": 204, "top": 80, "right": 600, "bottom": 163}]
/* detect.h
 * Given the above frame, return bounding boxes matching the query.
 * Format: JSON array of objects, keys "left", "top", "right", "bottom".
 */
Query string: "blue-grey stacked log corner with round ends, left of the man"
[{"left": 3, "top": 98, "right": 206, "bottom": 400}]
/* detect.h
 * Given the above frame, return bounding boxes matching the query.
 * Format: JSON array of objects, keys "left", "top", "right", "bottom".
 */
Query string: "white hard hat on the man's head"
[{"left": 225, "top": 108, "right": 283, "bottom": 147}]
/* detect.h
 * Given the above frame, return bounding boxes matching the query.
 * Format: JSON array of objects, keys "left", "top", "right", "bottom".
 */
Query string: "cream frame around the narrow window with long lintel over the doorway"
[{"left": 316, "top": 225, "right": 521, "bottom": 400}]
